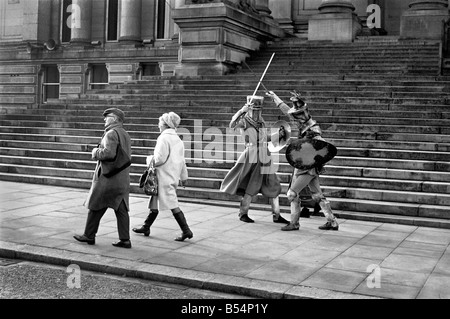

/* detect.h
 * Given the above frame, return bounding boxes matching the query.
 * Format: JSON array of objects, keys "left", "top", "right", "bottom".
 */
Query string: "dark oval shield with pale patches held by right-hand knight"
[{"left": 286, "top": 139, "right": 337, "bottom": 170}]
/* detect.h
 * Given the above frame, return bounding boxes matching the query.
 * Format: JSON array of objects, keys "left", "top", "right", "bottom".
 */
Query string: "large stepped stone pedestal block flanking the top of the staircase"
[{"left": 173, "top": 3, "right": 285, "bottom": 76}]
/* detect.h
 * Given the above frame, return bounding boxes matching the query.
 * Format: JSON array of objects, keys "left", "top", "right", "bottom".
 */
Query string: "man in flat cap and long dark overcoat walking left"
[{"left": 74, "top": 108, "right": 131, "bottom": 248}]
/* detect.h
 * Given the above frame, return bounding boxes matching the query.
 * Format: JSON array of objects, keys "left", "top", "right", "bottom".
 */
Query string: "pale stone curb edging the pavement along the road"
[{"left": 0, "top": 241, "right": 379, "bottom": 299}]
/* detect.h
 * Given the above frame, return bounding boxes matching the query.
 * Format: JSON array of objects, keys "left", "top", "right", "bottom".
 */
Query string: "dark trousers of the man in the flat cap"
[{"left": 84, "top": 201, "right": 130, "bottom": 240}]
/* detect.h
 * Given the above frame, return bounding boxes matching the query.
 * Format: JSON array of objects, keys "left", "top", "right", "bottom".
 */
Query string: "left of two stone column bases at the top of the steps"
[{"left": 308, "top": 0, "right": 361, "bottom": 42}]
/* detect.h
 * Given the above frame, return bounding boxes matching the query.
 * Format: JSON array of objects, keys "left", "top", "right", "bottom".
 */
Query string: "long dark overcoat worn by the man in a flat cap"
[{"left": 84, "top": 124, "right": 131, "bottom": 210}]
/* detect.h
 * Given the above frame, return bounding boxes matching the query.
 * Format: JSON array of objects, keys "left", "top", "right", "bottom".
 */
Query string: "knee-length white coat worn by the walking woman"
[{"left": 147, "top": 129, "right": 188, "bottom": 210}]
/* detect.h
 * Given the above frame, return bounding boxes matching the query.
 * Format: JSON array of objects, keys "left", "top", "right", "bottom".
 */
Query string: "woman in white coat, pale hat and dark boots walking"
[{"left": 133, "top": 112, "right": 194, "bottom": 241}]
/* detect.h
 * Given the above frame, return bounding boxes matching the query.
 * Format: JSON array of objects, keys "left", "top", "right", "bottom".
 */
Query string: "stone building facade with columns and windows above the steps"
[{"left": 0, "top": 0, "right": 449, "bottom": 107}]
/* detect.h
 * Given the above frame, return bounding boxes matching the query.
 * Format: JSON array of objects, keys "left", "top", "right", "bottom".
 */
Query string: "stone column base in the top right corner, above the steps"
[{"left": 400, "top": 0, "right": 450, "bottom": 40}]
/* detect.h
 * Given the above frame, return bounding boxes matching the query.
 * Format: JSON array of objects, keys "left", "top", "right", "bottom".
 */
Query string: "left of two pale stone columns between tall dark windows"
[{"left": 70, "top": 0, "right": 92, "bottom": 44}]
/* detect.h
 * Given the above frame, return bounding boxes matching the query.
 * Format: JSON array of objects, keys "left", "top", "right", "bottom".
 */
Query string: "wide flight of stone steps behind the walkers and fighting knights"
[{"left": 0, "top": 37, "right": 450, "bottom": 228}]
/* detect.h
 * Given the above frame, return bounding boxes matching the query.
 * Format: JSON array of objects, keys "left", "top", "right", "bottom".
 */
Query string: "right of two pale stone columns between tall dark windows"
[{"left": 119, "top": 0, "right": 142, "bottom": 43}]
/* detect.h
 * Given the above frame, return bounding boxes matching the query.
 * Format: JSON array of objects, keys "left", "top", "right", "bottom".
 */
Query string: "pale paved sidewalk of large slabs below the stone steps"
[{"left": 0, "top": 181, "right": 450, "bottom": 299}]
